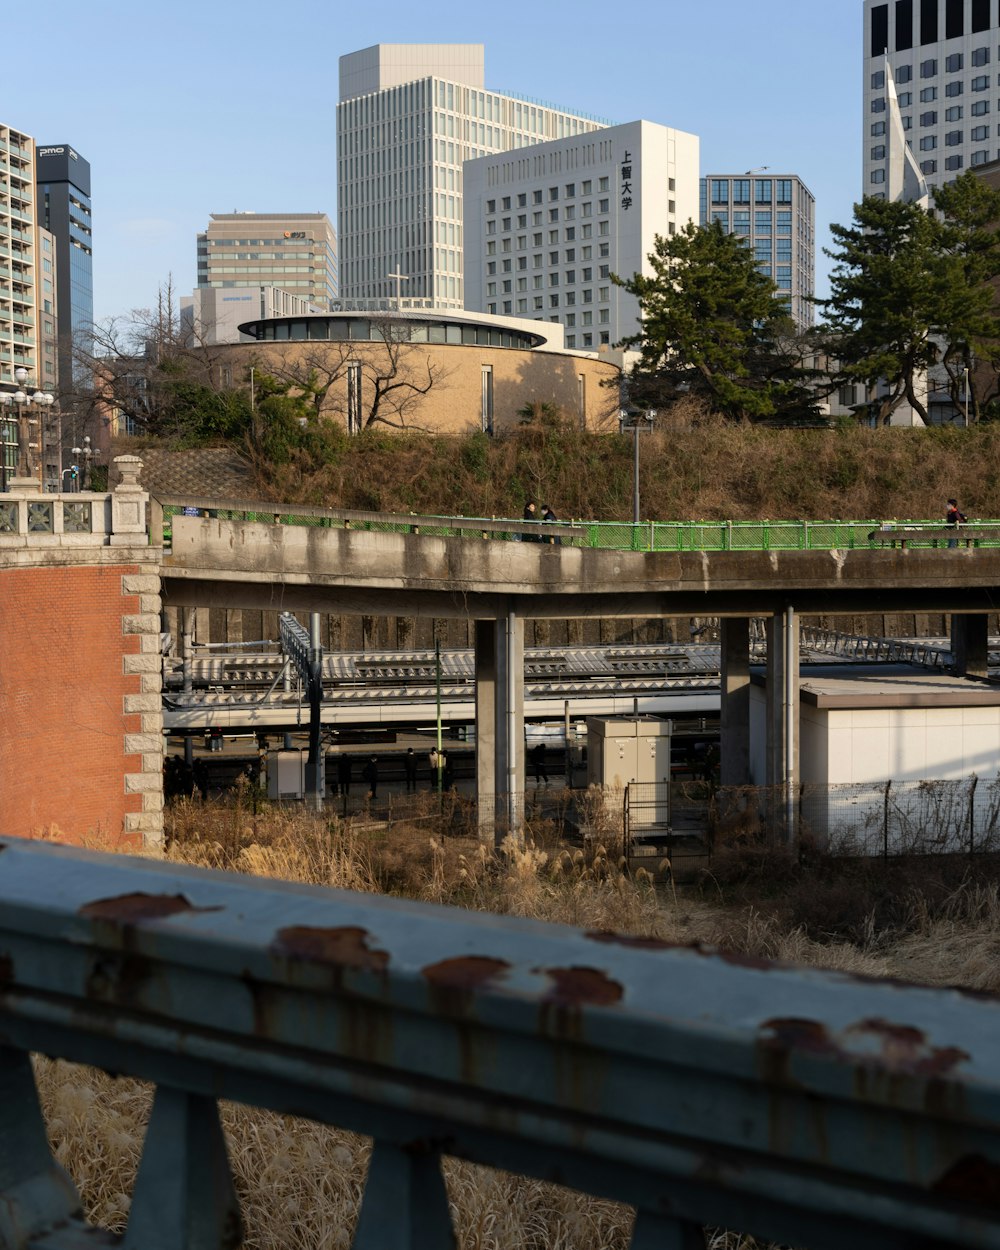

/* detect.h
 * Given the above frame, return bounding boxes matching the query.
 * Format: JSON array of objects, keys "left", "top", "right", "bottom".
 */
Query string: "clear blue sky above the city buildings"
[{"left": 13, "top": 0, "right": 863, "bottom": 320}]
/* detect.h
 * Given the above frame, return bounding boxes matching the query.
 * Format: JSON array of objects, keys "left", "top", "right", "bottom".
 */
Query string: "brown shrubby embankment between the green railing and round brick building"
[{"left": 238, "top": 418, "right": 1000, "bottom": 520}]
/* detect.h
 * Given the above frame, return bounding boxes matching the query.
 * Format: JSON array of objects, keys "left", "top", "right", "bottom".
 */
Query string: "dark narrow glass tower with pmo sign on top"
[{"left": 35, "top": 144, "right": 94, "bottom": 395}]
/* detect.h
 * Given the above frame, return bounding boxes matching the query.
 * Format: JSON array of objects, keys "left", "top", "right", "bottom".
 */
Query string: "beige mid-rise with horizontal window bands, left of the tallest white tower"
[{"left": 198, "top": 213, "right": 338, "bottom": 308}]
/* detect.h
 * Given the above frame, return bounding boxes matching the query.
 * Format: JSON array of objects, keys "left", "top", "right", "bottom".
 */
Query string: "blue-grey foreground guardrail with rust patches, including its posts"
[{"left": 0, "top": 839, "right": 1000, "bottom": 1250}]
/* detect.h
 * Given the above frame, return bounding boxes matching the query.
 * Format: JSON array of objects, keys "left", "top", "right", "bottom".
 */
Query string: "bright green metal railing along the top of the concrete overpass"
[{"left": 161, "top": 499, "right": 1000, "bottom": 551}]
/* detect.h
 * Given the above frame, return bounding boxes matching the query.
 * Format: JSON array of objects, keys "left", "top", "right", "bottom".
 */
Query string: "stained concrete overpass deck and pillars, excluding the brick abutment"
[{"left": 161, "top": 500, "right": 1000, "bottom": 830}]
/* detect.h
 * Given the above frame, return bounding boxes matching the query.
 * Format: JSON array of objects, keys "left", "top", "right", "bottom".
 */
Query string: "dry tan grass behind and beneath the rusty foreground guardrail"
[{"left": 36, "top": 803, "right": 1000, "bottom": 1250}]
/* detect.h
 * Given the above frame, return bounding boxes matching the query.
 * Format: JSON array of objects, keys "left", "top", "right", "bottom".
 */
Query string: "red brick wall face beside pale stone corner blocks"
[{"left": 0, "top": 565, "right": 143, "bottom": 846}]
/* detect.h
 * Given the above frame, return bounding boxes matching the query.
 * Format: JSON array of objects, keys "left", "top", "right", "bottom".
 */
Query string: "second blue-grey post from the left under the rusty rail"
[{"left": 123, "top": 1085, "right": 243, "bottom": 1250}]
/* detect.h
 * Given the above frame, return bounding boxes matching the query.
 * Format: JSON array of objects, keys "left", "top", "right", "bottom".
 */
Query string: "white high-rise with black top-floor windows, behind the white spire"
[{"left": 863, "top": 0, "right": 1000, "bottom": 196}]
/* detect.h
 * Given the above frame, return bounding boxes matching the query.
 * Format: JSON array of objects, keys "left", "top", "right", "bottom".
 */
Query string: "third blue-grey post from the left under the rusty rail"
[{"left": 351, "top": 1140, "right": 455, "bottom": 1250}]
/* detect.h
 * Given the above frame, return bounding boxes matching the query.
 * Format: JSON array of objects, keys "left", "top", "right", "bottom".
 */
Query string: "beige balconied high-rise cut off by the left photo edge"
[{"left": 0, "top": 123, "right": 39, "bottom": 483}]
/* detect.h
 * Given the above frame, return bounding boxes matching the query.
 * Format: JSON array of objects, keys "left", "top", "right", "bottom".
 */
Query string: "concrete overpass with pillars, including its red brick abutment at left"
[{"left": 0, "top": 456, "right": 1000, "bottom": 843}]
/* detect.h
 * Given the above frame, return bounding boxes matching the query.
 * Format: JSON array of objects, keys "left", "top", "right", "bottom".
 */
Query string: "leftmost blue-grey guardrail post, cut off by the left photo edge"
[{"left": 0, "top": 1046, "right": 81, "bottom": 1248}]
